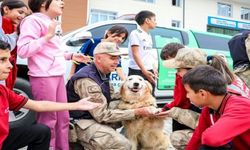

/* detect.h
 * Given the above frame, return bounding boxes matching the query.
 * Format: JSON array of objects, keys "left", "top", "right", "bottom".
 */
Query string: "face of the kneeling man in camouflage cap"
[{"left": 96, "top": 54, "right": 120, "bottom": 74}]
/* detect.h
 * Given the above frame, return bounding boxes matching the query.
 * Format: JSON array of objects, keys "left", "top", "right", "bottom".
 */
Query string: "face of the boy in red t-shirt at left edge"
[{"left": 0, "top": 50, "right": 13, "bottom": 80}]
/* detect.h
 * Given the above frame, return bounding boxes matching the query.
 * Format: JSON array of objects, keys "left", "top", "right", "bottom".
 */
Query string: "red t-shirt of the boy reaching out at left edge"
[{"left": 0, "top": 85, "right": 28, "bottom": 149}]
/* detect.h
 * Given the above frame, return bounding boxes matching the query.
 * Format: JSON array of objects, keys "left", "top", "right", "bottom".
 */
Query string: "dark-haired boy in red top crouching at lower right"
[{"left": 183, "top": 65, "right": 250, "bottom": 150}]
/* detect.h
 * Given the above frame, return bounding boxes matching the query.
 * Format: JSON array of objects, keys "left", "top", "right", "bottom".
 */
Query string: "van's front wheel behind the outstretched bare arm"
[{"left": 9, "top": 78, "right": 35, "bottom": 128}]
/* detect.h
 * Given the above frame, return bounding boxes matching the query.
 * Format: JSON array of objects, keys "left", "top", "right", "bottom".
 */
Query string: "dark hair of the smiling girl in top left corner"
[{"left": 1, "top": 0, "right": 28, "bottom": 15}]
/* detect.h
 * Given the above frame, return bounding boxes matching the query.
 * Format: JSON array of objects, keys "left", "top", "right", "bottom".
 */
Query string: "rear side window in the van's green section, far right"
[{"left": 193, "top": 32, "right": 230, "bottom": 51}]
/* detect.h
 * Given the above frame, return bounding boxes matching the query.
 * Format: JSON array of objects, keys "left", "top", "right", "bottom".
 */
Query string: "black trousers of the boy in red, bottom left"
[{"left": 2, "top": 124, "right": 51, "bottom": 150}]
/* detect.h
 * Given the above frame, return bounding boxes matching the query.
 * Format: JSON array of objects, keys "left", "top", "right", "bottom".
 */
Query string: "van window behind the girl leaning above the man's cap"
[{"left": 89, "top": 24, "right": 136, "bottom": 47}]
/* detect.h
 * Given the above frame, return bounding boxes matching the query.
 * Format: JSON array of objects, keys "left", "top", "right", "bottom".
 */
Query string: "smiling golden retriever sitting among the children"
[{"left": 118, "top": 75, "right": 168, "bottom": 150}]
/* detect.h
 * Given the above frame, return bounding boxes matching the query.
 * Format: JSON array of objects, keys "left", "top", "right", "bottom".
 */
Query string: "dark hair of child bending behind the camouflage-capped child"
[{"left": 160, "top": 43, "right": 184, "bottom": 60}]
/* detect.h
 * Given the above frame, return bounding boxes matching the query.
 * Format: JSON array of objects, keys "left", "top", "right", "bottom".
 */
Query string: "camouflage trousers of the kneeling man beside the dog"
[{"left": 76, "top": 119, "right": 131, "bottom": 150}]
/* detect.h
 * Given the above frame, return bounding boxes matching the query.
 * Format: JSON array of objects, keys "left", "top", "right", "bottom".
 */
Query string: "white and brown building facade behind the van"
[{"left": 22, "top": 0, "right": 250, "bottom": 35}]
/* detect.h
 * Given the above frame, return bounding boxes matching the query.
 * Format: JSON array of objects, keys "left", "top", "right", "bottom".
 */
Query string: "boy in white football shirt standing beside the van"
[{"left": 128, "top": 10, "right": 157, "bottom": 94}]
